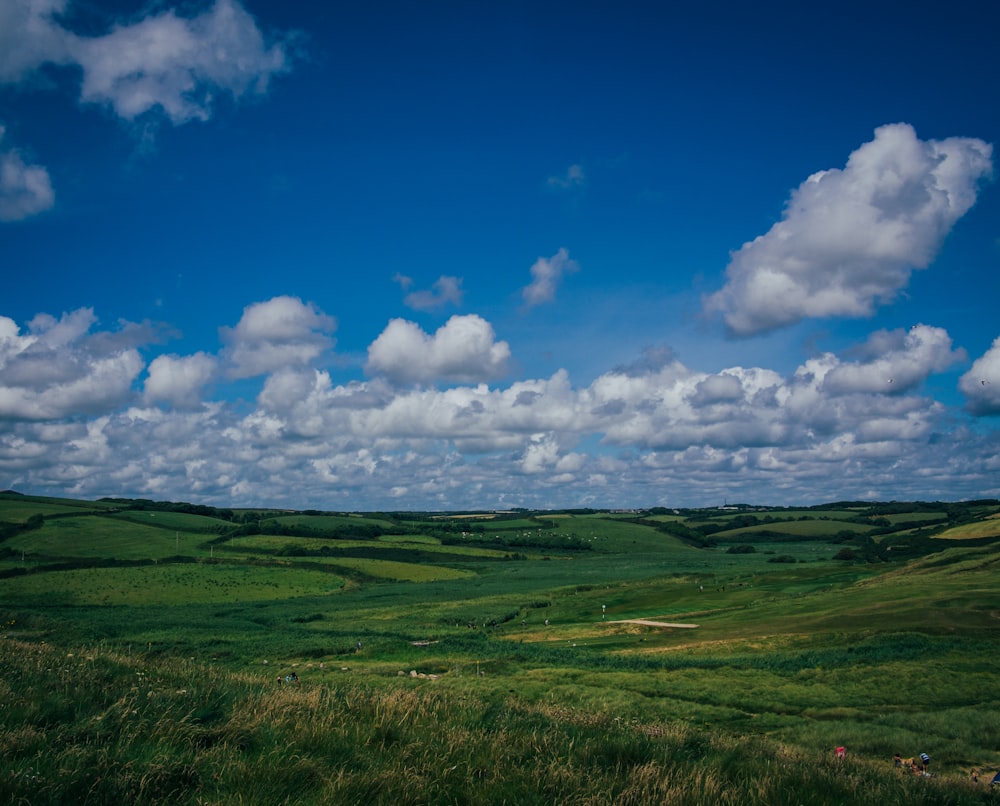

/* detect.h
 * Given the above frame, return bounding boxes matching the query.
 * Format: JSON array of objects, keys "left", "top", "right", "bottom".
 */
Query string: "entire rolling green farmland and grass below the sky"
[{"left": 0, "top": 493, "right": 1000, "bottom": 803}]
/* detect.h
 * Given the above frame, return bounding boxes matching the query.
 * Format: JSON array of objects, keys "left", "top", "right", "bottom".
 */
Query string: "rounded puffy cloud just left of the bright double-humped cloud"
[{"left": 220, "top": 296, "right": 337, "bottom": 378}]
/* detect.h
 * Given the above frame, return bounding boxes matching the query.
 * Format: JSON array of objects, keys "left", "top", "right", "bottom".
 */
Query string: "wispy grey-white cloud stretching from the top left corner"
[{"left": 0, "top": 0, "right": 290, "bottom": 124}]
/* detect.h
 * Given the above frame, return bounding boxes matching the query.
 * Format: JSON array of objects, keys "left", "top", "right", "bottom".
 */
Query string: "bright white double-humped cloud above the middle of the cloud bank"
[{"left": 366, "top": 314, "right": 510, "bottom": 383}]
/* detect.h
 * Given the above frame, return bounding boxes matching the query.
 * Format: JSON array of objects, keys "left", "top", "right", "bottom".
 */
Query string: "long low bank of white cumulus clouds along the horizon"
[{"left": 0, "top": 304, "right": 1000, "bottom": 509}]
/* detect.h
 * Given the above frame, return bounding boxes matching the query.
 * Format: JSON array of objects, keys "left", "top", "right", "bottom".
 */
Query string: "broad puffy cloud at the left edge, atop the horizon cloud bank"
[{"left": 0, "top": 308, "right": 143, "bottom": 421}]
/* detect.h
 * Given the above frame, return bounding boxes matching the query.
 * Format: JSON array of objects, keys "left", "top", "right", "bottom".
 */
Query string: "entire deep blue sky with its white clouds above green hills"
[{"left": 0, "top": 0, "right": 1000, "bottom": 510}]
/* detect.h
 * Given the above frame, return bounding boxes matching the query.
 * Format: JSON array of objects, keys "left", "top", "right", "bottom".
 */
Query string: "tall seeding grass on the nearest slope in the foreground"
[{"left": 0, "top": 635, "right": 1000, "bottom": 806}]
